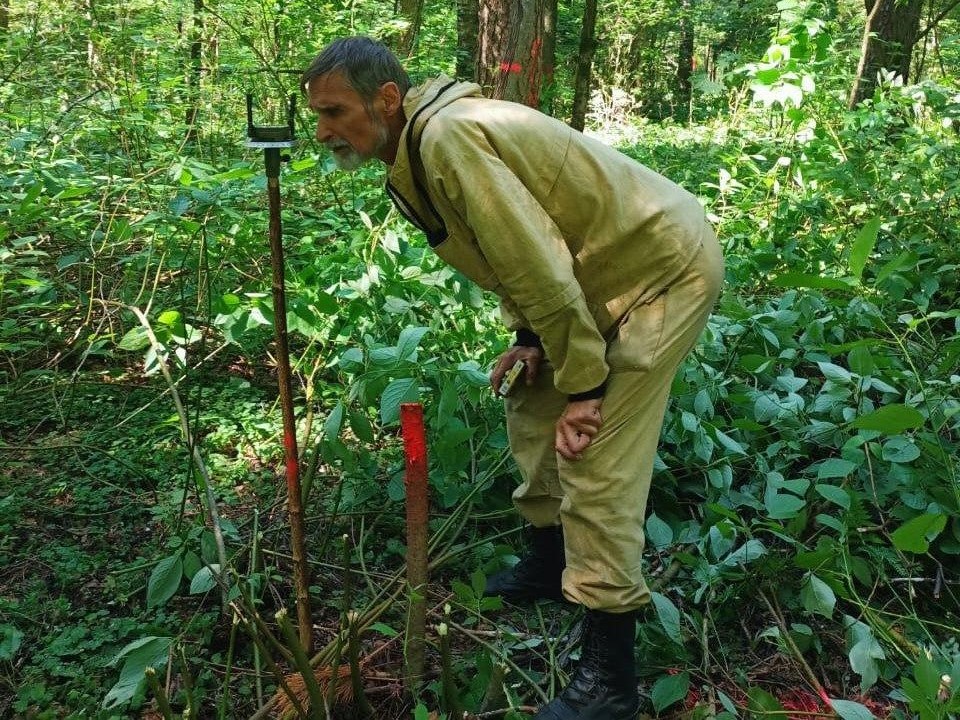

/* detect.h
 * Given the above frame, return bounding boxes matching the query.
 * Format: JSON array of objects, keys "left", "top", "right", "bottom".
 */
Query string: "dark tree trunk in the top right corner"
[{"left": 848, "top": 0, "right": 923, "bottom": 109}]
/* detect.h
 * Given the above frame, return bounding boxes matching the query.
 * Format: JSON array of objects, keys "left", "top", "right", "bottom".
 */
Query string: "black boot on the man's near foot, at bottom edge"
[{"left": 533, "top": 610, "right": 640, "bottom": 720}]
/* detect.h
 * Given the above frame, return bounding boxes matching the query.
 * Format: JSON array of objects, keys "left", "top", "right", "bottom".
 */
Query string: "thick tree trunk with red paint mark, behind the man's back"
[{"left": 477, "top": 0, "right": 545, "bottom": 107}]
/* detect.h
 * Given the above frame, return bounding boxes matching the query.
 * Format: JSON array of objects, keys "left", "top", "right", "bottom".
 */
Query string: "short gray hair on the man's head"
[{"left": 300, "top": 35, "right": 410, "bottom": 104}]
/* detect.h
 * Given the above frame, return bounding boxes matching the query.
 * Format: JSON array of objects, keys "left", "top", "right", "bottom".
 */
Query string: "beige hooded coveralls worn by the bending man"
[{"left": 387, "top": 77, "right": 723, "bottom": 612}]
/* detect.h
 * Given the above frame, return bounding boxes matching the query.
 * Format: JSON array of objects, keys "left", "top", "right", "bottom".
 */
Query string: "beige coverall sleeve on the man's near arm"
[{"left": 422, "top": 122, "right": 609, "bottom": 394}]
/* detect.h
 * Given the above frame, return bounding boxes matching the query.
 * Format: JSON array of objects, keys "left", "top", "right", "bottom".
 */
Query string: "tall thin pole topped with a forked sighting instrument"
[{"left": 247, "top": 93, "right": 313, "bottom": 654}]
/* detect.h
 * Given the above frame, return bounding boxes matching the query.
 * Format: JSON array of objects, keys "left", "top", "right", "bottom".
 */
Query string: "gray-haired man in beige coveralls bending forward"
[{"left": 302, "top": 37, "right": 723, "bottom": 720}]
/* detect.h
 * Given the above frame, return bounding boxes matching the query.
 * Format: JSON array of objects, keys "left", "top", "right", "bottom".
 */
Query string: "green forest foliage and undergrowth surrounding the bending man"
[{"left": 0, "top": 2, "right": 960, "bottom": 720}]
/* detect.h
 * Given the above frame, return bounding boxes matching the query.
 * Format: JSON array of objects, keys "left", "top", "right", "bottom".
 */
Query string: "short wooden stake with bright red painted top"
[{"left": 400, "top": 403, "right": 430, "bottom": 696}]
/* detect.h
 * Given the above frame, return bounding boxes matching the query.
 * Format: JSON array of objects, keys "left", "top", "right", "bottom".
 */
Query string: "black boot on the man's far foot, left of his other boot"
[{"left": 483, "top": 526, "right": 566, "bottom": 603}]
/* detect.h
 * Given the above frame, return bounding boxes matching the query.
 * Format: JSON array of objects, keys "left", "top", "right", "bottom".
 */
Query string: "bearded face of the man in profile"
[{"left": 307, "top": 71, "right": 392, "bottom": 170}]
